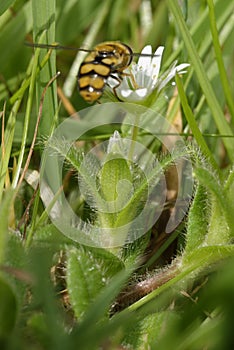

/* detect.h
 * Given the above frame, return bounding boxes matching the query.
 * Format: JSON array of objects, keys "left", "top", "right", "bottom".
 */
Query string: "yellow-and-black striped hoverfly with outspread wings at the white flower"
[{"left": 27, "top": 41, "right": 159, "bottom": 103}]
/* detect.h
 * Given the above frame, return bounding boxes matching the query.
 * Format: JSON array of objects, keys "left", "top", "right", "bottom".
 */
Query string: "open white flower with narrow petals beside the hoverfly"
[{"left": 116, "top": 45, "right": 189, "bottom": 102}]
